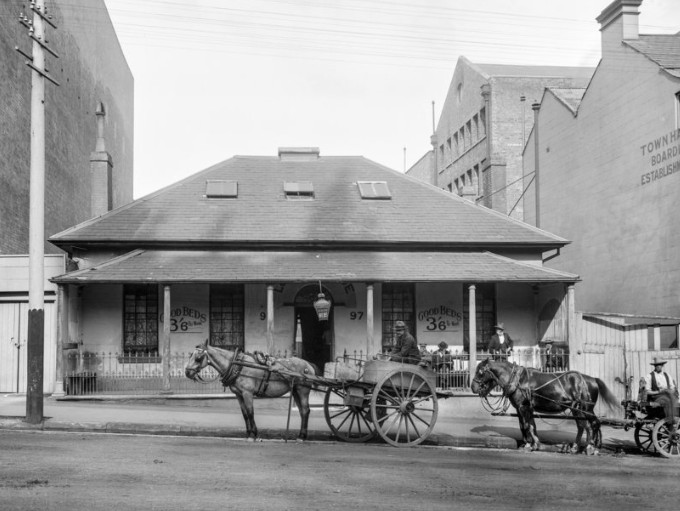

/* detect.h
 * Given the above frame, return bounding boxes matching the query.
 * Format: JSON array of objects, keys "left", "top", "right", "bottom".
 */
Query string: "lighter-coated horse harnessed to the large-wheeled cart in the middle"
[{"left": 184, "top": 341, "right": 316, "bottom": 441}]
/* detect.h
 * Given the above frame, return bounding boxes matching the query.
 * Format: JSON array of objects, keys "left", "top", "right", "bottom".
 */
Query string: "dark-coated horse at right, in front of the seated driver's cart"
[{"left": 471, "top": 359, "right": 618, "bottom": 454}]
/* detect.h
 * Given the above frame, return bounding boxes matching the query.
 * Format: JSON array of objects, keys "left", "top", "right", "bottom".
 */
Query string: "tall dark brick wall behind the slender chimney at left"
[{"left": 0, "top": 0, "right": 134, "bottom": 254}]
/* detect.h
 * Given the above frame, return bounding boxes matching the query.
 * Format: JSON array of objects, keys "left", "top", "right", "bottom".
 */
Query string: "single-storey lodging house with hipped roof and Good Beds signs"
[{"left": 50, "top": 148, "right": 579, "bottom": 392}]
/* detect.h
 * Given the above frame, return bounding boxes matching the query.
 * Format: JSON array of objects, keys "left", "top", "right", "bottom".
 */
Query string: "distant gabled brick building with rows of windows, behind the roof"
[{"left": 407, "top": 57, "right": 593, "bottom": 219}]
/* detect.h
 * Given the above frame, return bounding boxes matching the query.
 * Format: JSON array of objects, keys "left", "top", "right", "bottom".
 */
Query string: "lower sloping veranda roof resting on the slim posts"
[{"left": 52, "top": 249, "right": 580, "bottom": 284}]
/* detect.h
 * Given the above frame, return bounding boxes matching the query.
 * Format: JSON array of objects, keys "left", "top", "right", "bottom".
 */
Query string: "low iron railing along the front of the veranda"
[{"left": 64, "top": 348, "right": 569, "bottom": 395}]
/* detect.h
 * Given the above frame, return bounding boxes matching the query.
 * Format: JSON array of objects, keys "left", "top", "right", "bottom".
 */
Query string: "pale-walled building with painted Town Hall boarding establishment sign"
[{"left": 524, "top": 0, "right": 680, "bottom": 326}]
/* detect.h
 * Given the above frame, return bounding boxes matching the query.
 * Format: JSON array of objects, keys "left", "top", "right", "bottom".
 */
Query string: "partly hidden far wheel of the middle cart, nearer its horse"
[{"left": 323, "top": 387, "right": 375, "bottom": 442}]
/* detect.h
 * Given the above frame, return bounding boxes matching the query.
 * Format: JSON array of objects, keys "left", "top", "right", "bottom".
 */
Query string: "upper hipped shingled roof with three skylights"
[{"left": 50, "top": 155, "right": 568, "bottom": 250}]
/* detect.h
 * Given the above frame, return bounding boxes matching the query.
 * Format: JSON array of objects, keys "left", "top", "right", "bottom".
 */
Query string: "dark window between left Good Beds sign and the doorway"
[{"left": 210, "top": 284, "right": 244, "bottom": 350}]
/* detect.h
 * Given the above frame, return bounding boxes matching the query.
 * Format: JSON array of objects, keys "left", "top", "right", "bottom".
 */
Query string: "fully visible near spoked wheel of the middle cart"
[{"left": 371, "top": 368, "right": 439, "bottom": 447}]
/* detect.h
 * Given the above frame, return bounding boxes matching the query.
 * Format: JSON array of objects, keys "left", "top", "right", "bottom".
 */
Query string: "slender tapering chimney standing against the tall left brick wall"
[{"left": 90, "top": 102, "right": 113, "bottom": 217}]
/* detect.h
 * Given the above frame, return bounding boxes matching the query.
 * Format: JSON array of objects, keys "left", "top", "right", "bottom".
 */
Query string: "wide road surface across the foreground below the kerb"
[{"left": 0, "top": 430, "right": 680, "bottom": 511}]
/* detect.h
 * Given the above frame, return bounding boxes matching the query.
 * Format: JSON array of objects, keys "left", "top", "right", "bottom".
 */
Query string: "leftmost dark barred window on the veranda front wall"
[{"left": 123, "top": 284, "right": 158, "bottom": 356}]
